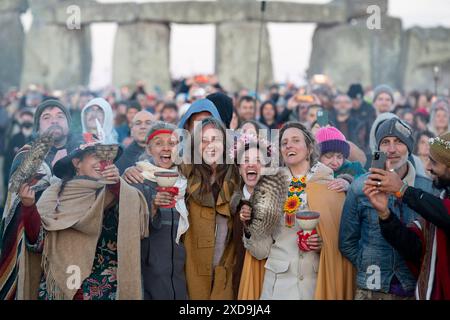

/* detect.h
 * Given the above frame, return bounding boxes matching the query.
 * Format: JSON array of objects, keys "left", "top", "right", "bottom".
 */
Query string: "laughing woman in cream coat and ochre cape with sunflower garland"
[{"left": 244, "top": 122, "right": 353, "bottom": 300}]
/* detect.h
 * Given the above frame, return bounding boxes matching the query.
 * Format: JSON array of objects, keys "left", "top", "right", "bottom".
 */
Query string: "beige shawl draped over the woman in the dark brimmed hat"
[{"left": 31, "top": 179, "right": 149, "bottom": 300}]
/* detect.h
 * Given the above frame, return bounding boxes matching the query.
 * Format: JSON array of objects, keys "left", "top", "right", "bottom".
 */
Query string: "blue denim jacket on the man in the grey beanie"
[{"left": 339, "top": 169, "right": 433, "bottom": 293}]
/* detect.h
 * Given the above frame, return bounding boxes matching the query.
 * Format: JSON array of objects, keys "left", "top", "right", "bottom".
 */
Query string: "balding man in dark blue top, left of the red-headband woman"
[{"left": 116, "top": 110, "right": 155, "bottom": 174}]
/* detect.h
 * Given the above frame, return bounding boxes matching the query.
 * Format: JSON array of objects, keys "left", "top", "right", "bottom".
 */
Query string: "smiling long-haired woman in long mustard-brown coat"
[{"left": 182, "top": 118, "right": 239, "bottom": 300}]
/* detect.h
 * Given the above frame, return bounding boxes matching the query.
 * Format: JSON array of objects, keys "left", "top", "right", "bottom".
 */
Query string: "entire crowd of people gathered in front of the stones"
[{"left": 0, "top": 76, "right": 450, "bottom": 300}]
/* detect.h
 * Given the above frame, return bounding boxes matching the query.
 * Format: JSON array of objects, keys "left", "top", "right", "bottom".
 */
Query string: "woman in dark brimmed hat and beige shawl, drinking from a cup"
[{"left": 20, "top": 145, "right": 149, "bottom": 300}]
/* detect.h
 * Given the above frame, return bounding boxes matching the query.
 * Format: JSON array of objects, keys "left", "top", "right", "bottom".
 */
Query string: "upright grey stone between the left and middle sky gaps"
[{"left": 113, "top": 22, "right": 170, "bottom": 91}]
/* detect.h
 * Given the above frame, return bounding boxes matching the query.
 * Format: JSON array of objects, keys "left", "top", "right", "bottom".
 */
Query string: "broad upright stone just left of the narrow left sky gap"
[{"left": 22, "top": 22, "right": 91, "bottom": 90}]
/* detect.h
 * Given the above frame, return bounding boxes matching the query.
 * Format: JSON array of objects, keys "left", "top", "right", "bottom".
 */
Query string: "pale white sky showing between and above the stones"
[{"left": 23, "top": 0, "right": 450, "bottom": 89}]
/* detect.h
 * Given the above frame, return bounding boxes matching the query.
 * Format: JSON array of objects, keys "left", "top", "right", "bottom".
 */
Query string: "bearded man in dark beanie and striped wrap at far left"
[{"left": 0, "top": 100, "right": 81, "bottom": 300}]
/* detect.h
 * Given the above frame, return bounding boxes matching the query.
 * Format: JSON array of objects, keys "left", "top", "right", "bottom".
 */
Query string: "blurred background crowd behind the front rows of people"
[{"left": 0, "top": 76, "right": 450, "bottom": 206}]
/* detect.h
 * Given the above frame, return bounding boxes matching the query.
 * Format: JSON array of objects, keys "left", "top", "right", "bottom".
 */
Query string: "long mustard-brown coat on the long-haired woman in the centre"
[{"left": 184, "top": 166, "right": 239, "bottom": 300}]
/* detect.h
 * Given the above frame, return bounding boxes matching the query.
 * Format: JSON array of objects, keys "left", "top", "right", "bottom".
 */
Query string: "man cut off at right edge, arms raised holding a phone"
[{"left": 364, "top": 132, "right": 450, "bottom": 300}]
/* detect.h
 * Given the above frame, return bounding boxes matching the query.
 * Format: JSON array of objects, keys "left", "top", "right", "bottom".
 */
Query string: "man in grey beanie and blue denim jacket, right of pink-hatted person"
[{"left": 339, "top": 118, "right": 433, "bottom": 300}]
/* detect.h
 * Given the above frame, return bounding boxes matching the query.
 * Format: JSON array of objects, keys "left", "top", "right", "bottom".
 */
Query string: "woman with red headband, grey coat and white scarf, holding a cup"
[{"left": 125, "top": 121, "right": 189, "bottom": 300}]
